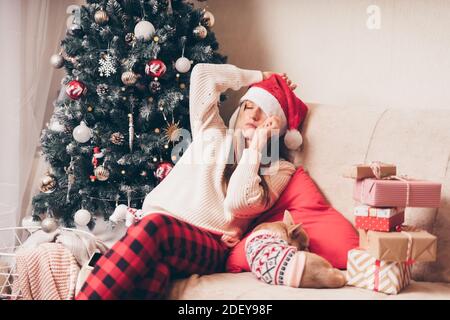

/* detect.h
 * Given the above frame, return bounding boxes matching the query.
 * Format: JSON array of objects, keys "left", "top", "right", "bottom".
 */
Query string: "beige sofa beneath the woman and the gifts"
[{"left": 170, "top": 104, "right": 450, "bottom": 300}]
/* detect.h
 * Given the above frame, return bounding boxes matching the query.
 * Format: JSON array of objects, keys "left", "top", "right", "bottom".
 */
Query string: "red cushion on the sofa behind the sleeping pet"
[{"left": 227, "top": 167, "right": 359, "bottom": 272}]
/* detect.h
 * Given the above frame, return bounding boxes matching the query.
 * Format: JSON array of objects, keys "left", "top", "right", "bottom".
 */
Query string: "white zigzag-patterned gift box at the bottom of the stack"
[{"left": 347, "top": 248, "right": 411, "bottom": 294}]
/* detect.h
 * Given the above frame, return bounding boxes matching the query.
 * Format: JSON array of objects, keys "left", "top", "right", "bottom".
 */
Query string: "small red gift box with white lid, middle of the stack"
[{"left": 354, "top": 206, "right": 405, "bottom": 231}]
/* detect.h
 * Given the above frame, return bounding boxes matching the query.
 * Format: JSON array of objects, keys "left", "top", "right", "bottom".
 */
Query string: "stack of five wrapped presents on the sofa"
[{"left": 344, "top": 162, "right": 441, "bottom": 294}]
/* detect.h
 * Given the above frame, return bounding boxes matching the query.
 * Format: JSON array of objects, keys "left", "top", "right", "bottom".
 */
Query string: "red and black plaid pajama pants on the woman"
[{"left": 76, "top": 213, "right": 228, "bottom": 300}]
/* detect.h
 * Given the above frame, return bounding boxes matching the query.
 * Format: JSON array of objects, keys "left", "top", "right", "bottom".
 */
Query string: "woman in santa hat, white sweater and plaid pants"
[{"left": 77, "top": 64, "right": 307, "bottom": 299}]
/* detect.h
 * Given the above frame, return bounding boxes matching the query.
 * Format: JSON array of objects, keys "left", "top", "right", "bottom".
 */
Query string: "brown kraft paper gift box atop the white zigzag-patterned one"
[{"left": 358, "top": 229, "right": 437, "bottom": 262}]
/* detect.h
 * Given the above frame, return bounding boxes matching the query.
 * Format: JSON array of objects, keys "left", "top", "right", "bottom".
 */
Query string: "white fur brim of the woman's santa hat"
[{"left": 238, "top": 87, "right": 287, "bottom": 136}]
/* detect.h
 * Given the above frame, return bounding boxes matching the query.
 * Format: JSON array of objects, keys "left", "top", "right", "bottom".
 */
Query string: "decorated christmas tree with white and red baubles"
[{"left": 28, "top": 0, "right": 226, "bottom": 229}]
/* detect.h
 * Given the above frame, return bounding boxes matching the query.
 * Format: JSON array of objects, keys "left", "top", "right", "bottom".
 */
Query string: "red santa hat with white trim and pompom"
[{"left": 229, "top": 74, "right": 308, "bottom": 150}]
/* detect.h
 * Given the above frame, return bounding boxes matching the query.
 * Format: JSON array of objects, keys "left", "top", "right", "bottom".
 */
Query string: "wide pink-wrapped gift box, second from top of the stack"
[{"left": 353, "top": 177, "right": 441, "bottom": 208}]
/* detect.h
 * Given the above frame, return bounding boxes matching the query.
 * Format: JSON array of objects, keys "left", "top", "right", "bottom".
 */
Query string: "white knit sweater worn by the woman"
[{"left": 142, "top": 63, "right": 295, "bottom": 246}]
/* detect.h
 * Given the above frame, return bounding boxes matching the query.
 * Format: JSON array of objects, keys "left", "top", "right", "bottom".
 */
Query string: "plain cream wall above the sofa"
[{"left": 203, "top": 0, "right": 450, "bottom": 117}]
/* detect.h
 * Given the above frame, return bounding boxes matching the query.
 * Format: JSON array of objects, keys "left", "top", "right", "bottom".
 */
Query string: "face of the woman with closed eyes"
[{"left": 235, "top": 100, "right": 267, "bottom": 139}]
